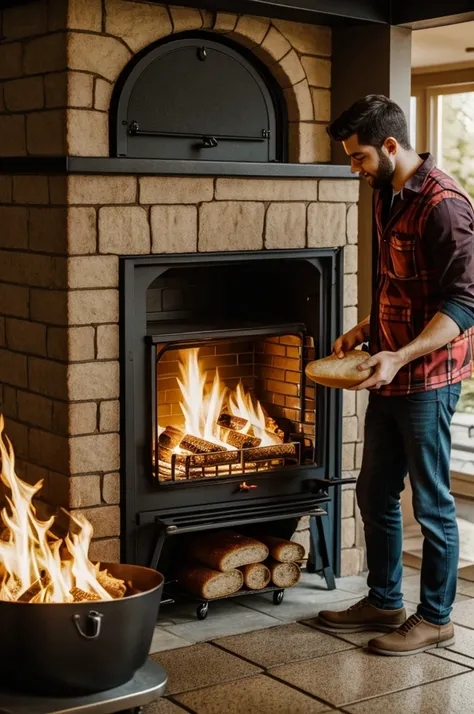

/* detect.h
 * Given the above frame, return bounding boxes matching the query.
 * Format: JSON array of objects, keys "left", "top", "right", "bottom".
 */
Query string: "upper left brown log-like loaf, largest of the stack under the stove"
[{"left": 188, "top": 531, "right": 268, "bottom": 572}]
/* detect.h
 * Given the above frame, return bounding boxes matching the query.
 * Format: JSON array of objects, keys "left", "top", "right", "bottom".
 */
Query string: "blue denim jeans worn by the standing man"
[{"left": 357, "top": 384, "right": 461, "bottom": 625}]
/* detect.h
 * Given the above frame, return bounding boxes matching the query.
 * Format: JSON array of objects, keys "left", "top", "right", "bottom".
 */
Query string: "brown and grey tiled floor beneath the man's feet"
[{"left": 145, "top": 568, "right": 474, "bottom": 714}]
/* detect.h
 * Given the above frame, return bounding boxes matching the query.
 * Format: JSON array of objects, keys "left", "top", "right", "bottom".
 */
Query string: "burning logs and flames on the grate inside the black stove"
[{"left": 158, "top": 348, "right": 300, "bottom": 481}]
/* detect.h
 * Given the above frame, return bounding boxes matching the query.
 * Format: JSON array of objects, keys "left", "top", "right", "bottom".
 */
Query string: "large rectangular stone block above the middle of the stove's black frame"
[{"left": 198, "top": 201, "right": 265, "bottom": 252}]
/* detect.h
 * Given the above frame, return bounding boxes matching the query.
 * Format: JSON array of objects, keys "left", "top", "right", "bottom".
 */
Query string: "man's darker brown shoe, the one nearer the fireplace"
[{"left": 318, "top": 597, "right": 407, "bottom": 632}]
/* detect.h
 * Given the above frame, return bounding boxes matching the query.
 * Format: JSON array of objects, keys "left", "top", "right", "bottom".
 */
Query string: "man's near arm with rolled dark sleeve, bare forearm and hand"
[{"left": 356, "top": 199, "right": 474, "bottom": 389}]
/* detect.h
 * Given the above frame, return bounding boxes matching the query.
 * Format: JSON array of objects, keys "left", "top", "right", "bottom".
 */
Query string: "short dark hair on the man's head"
[{"left": 327, "top": 94, "right": 411, "bottom": 149}]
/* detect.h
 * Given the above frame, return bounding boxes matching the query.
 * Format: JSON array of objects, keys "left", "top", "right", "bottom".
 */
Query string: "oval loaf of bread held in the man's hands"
[{"left": 305, "top": 350, "right": 374, "bottom": 389}]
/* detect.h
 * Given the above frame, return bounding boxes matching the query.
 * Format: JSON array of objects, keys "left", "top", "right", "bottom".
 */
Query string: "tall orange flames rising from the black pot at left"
[{"left": 0, "top": 415, "right": 112, "bottom": 603}]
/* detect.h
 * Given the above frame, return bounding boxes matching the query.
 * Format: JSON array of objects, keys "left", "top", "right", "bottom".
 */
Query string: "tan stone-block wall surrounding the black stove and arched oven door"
[{"left": 0, "top": 0, "right": 363, "bottom": 574}]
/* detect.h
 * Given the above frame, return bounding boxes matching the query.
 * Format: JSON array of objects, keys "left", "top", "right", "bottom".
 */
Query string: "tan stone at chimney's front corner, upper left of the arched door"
[{"left": 68, "top": 32, "right": 131, "bottom": 81}]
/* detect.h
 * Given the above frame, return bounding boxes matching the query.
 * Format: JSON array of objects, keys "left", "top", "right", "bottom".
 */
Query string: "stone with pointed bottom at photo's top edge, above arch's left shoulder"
[{"left": 105, "top": 0, "right": 173, "bottom": 52}]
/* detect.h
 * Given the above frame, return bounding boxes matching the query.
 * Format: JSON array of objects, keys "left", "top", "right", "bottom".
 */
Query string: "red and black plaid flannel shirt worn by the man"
[{"left": 370, "top": 154, "right": 474, "bottom": 396}]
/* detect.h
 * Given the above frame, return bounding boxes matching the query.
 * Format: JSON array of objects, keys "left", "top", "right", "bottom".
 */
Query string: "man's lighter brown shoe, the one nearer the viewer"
[{"left": 367, "top": 613, "right": 454, "bottom": 657}]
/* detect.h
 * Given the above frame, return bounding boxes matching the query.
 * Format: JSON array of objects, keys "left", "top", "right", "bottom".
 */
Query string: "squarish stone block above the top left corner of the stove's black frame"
[{"left": 99, "top": 206, "right": 150, "bottom": 255}]
